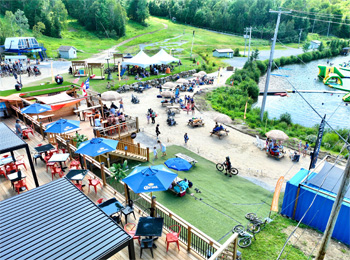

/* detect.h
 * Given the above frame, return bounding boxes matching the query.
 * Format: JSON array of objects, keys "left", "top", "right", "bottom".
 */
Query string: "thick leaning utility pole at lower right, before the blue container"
[{"left": 316, "top": 145, "right": 350, "bottom": 260}]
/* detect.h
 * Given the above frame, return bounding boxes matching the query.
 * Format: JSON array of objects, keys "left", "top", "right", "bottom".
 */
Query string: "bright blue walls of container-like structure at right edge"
[{"left": 281, "top": 169, "right": 350, "bottom": 245}]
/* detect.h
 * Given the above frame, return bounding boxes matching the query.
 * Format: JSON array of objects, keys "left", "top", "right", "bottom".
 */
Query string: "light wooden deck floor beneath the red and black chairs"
[{"left": 0, "top": 118, "right": 203, "bottom": 260}]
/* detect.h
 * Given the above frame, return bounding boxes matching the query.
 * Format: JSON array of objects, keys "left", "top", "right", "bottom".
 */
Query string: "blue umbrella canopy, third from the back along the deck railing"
[{"left": 75, "top": 138, "right": 119, "bottom": 157}]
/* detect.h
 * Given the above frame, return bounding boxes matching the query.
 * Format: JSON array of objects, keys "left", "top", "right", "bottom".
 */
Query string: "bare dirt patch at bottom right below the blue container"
[{"left": 283, "top": 226, "right": 350, "bottom": 260}]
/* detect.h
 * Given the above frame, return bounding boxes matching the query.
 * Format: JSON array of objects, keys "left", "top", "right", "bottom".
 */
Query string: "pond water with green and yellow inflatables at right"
[{"left": 254, "top": 56, "right": 350, "bottom": 128}]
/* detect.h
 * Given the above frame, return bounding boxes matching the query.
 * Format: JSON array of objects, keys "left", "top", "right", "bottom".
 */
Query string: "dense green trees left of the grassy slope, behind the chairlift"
[{"left": 0, "top": 0, "right": 149, "bottom": 42}]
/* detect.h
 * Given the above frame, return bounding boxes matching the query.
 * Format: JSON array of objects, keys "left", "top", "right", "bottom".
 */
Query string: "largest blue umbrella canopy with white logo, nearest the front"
[{"left": 123, "top": 165, "right": 177, "bottom": 193}]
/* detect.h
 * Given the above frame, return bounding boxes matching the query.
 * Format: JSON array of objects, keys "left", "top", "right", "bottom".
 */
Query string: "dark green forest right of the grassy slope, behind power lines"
[{"left": 149, "top": 0, "right": 350, "bottom": 42}]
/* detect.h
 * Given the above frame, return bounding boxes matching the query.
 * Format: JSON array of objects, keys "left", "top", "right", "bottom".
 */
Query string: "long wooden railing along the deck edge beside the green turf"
[{"left": 12, "top": 107, "right": 230, "bottom": 259}]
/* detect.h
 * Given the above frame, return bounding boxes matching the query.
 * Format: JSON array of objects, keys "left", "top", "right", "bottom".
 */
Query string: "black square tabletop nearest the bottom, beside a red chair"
[{"left": 135, "top": 217, "right": 164, "bottom": 248}]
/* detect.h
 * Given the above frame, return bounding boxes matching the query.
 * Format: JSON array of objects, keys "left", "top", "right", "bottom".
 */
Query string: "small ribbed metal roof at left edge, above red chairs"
[{"left": 0, "top": 122, "right": 27, "bottom": 154}]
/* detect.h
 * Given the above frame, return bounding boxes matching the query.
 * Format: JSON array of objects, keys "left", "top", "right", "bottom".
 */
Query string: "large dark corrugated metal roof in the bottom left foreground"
[{"left": 0, "top": 178, "right": 132, "bottom": 260}]
